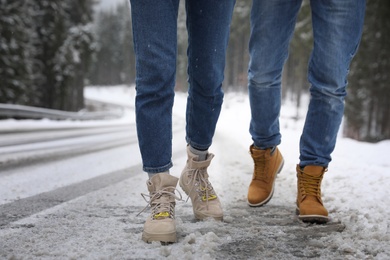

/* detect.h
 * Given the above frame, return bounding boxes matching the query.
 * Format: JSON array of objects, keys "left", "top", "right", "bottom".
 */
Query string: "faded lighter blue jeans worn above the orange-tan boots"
[{"left": 248, "top": 0, "right": 365, "bottom": 167}]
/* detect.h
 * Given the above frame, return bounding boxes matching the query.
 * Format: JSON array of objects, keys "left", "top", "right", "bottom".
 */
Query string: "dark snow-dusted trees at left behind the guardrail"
[{"left": 0, "top": 0, "right": 93, "bottom": 111}]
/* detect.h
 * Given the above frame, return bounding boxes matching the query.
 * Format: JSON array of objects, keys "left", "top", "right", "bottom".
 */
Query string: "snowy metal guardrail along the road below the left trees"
[{"left": 0, "top": 104, "right": 123, "bottom": 120}]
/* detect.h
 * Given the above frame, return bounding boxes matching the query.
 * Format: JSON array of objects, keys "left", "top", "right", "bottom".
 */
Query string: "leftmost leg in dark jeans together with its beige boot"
[{"left": 130, "top": 0, "right": 179, "bottom": 242}]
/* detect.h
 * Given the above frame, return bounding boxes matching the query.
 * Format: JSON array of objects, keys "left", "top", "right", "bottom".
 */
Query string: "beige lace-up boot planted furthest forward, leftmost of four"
[{"left": 141, "top": 173, "right": 181, "bottom": 243}]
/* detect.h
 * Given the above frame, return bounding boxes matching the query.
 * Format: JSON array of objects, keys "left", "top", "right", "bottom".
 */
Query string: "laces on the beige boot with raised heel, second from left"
[{"left": 182, "top": 168, "right": 217, "bottom": 206}]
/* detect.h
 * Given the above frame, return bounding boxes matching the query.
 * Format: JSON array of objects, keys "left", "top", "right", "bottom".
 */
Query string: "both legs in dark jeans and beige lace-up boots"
[{"left": 130, "top": 0, "right": 235, "bottom": 242}]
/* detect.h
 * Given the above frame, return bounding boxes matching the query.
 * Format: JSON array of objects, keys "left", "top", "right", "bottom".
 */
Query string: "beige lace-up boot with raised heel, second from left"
[{"left": 179, "top": 147, "right": 223, "bottom": 220}]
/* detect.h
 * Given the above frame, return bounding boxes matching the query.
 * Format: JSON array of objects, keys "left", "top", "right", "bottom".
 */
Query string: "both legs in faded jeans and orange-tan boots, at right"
[{"left": 248, "top": 0, "right": 365, "bottom": 223}]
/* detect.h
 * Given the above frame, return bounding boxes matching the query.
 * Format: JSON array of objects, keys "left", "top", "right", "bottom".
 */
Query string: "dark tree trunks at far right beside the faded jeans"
[{"left": 344, "top": 0, "right": 390, "bottom": 142}]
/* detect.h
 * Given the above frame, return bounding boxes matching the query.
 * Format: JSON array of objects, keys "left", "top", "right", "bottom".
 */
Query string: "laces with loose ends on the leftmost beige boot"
[{"left": 137, "top": 187, "right": 183, "bottom": 219}]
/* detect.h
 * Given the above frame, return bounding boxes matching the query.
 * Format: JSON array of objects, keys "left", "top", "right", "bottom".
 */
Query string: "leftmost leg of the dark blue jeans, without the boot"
[{"left": 131, "top": 0, "right": 179, "bottom": 173}]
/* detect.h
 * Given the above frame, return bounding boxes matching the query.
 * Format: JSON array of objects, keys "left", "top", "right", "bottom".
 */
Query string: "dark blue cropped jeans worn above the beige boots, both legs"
[{"left": 130, "top": 0, "right": 235, "bottom": 173}]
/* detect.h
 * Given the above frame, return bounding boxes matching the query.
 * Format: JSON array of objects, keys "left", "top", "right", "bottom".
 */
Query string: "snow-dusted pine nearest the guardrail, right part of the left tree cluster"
[{"left": 34, "top": 0, "right": 93, "bottom": 111}]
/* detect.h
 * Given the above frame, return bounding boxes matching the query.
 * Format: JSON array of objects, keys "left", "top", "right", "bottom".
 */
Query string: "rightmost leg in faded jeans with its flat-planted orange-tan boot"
[{"left": 297, "top": 0, "right": 365, "bottom": 222}]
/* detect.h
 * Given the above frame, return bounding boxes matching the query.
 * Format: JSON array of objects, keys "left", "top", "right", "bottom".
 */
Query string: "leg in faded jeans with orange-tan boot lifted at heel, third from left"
[{"left": 248, "top": 0, "right": 302, "bottom": 206}]
